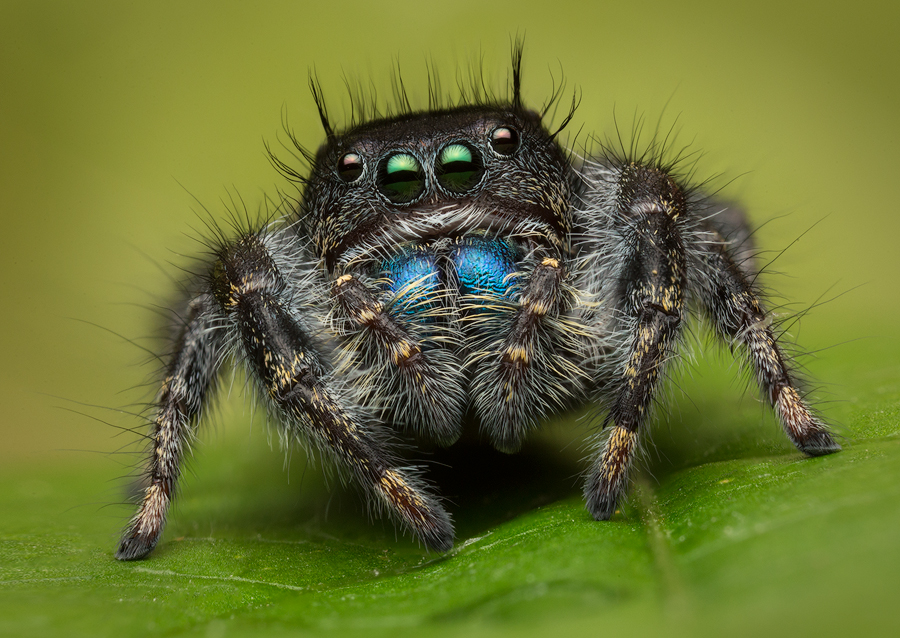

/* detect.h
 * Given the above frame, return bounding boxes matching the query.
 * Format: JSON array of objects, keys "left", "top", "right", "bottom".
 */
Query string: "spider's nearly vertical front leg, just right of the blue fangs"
[{"left": 584, "top": 164, "right": 687, "bottom": 520}]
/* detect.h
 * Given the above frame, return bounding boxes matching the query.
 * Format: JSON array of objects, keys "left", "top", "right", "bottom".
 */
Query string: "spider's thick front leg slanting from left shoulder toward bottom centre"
[{"left": 213, "top": 234, "right": 453, "bottom": 551}]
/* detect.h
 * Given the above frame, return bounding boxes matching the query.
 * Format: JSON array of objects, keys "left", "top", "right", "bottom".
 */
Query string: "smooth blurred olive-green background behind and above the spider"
[{"left": 0, "top": 0, "right": 900, "bottom": 636}]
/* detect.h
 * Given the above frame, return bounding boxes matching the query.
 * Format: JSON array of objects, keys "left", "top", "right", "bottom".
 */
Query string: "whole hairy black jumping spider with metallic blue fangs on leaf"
[{"left": 116, "top": 53, "right": 840, "bottom": 560}]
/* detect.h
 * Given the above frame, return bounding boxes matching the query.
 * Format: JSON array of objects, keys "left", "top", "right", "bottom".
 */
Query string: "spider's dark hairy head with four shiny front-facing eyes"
[{"left": 303, "top": 103, "right": 571, "bottom": 269}]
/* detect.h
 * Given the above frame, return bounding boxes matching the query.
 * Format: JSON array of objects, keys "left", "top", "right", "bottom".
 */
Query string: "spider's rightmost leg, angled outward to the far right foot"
[{"left": 700, "top": 222, "right": 841, "bottom": 456}]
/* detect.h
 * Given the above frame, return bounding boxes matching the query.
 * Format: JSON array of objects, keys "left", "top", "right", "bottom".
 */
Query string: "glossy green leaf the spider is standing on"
[{"left": 0, "top": 338, "right": 900, "bottom": 636}]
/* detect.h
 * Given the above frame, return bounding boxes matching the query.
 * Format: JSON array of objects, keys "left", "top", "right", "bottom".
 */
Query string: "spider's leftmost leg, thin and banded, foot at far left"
[{"left": 116, "top": 294, "right": 222, "bottom": 560}]
